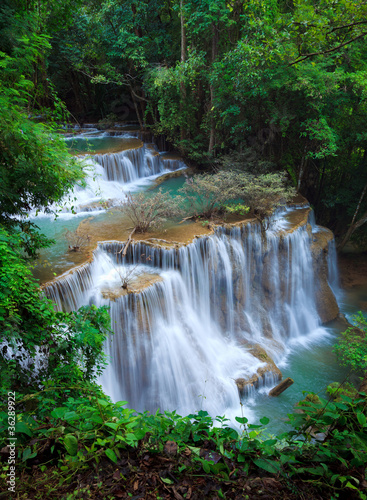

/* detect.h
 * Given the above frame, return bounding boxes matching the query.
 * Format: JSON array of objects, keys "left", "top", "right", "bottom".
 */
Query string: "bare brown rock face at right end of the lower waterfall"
[{"left": 311, "top": 228, "right": 339, "bottom": 323}]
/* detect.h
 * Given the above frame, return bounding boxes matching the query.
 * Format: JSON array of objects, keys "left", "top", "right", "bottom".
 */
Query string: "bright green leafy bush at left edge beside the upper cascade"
[{"left": 0, "top": 93, "right": 83, "bottom": 254}]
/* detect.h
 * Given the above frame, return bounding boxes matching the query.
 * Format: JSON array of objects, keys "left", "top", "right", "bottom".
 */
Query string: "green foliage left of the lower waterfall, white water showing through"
[{"left": 0, "top": 226, "right": 110, "bottom": 400}]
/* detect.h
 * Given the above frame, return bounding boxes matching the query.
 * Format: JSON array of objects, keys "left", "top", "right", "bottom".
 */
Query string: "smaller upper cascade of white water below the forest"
[{"left": 30, "top": 130, "right": 187, "bottom": 217}]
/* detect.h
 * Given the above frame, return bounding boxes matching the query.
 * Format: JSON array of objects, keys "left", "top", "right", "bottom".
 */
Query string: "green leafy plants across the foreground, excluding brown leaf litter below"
[{"left": 0, "top": 388, "right": 367, "bottom": 500}]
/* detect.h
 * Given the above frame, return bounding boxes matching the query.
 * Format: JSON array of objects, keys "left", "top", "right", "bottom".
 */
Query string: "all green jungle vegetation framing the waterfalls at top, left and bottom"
[{"left": 0, "top": 0, "right": 367, "bottom": 499}]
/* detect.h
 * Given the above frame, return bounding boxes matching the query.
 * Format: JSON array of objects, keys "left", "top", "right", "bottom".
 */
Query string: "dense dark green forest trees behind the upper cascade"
[{"left": 0, "top": 0, "right": 367, "bottom": 244}]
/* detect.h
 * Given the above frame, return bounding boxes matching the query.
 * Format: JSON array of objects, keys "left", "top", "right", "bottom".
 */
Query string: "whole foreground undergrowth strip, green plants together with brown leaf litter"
[{"left": 0, "top": 385, "right": 367, "bottom": 500}]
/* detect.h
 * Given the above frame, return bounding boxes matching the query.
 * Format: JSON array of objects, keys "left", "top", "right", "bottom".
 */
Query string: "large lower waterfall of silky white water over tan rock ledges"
[{"left": 45, "top": 207, "right": 338, "bottom": 418}]
